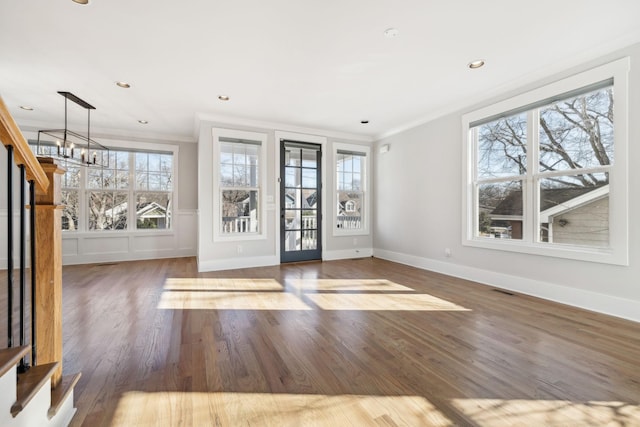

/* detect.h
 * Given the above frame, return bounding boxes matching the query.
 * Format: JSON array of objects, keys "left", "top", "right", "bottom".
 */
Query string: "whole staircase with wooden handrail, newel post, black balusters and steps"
[{"left": 0, "top": 98, "right": 80, "bottom": 427}]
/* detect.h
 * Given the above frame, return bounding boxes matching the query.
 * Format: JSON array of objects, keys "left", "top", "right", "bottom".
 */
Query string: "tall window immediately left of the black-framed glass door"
[{"left": 213, "top": 129, "right": 266, "bottom": 239}]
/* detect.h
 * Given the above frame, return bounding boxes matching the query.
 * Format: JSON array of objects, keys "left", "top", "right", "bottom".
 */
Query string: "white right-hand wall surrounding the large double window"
[{"left": 373, "top": 45, "right": 640, "bottom": 321}]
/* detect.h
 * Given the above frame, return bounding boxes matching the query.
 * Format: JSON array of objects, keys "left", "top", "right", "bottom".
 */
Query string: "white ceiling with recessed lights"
[{"left": 0, "top": 0, "right": 640, "bottom": 145}]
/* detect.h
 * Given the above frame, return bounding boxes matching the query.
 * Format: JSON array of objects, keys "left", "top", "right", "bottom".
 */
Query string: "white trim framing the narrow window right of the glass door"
[{"left": 331, "top": 142, "right": 371, "bottom": 237}]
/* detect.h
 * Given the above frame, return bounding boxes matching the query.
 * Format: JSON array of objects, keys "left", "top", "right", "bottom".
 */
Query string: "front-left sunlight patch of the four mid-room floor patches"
[{"left": 158, "top": 291, "right": 311, "bottom": 310}]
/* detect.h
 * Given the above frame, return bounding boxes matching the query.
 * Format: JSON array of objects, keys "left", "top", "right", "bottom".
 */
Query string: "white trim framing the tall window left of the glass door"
[{"left": 211, "top": 128, "right": 267, "bottom": 242}]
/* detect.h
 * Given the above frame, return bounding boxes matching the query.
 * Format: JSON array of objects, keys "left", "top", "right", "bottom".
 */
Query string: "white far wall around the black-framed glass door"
[{"left": 198, "top": 120, "right": 372, "bottom": 271}]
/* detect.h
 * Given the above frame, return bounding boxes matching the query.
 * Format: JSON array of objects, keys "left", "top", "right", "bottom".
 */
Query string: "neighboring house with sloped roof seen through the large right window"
[{"left": 489, "top": 185, "right": 609, "bottom": 246}]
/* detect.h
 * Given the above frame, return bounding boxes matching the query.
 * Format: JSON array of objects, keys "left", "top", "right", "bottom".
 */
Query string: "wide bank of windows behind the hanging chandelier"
[{"left": 31, "top": 142, "right": 177, "bottom": 232}]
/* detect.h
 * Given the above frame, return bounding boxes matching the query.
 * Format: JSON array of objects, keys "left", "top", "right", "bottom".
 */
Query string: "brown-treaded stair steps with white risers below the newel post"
[{"left": 0, "top": 346, "right": 80, "bottom": 427}]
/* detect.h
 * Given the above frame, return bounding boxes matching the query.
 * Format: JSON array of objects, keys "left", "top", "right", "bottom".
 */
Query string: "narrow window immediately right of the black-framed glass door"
[{"left": 334, "top": 144, "right": 369, "bottom": 235}]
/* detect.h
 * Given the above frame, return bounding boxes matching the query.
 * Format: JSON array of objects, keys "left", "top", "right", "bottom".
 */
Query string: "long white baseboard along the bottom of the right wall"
[{"left": 373, "top": 249, "right": 640, "bottom": 322}]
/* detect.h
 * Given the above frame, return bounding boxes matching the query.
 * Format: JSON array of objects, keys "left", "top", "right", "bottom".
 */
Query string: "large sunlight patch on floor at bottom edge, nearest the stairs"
[{"left": 111, "top": 392, "right": 453, "bottom": 427}]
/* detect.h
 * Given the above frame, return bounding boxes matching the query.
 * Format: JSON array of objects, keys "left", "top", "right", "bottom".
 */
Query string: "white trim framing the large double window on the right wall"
[{"left": 462, "top": 57, "right": 630, "bottom": 265}]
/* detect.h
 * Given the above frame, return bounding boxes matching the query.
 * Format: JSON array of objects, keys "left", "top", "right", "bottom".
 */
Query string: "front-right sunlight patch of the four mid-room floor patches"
[{"left": 306, "top": 294, "right": 471, "bottom": 311}]
